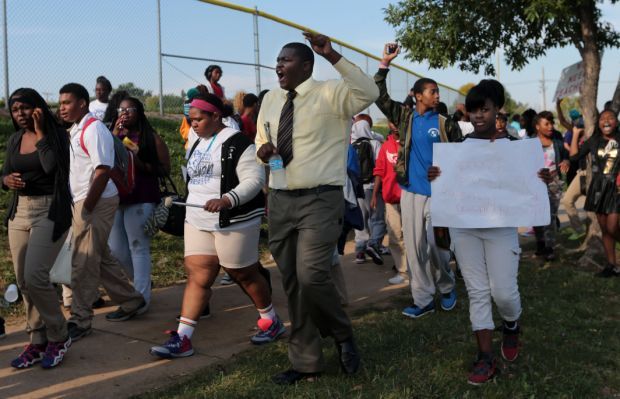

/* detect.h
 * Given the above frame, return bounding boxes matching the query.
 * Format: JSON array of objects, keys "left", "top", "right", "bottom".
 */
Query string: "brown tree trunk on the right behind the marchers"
[{"left": 576, "top": 2, "right": 605, "bottom": 263}]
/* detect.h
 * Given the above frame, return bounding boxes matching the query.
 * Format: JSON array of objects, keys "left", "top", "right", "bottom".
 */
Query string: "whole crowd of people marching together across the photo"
[{"left": 2, "top": 33, "right": 620, "bottom": 385}]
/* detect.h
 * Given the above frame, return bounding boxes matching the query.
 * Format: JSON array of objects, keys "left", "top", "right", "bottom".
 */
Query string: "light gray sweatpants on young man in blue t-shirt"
[{"left": 400, "top": 190, "right": 455, "bottom": 308}]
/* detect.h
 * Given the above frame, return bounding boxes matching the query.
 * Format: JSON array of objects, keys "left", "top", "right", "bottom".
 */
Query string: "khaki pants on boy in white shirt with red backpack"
[{"left": 69, "top": 196, "right": 144, "bottom": 328}]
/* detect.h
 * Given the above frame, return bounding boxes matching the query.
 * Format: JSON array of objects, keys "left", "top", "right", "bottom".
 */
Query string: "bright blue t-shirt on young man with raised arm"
[{"left": 402, "top": 111, "right": 441, "bottom": 197}]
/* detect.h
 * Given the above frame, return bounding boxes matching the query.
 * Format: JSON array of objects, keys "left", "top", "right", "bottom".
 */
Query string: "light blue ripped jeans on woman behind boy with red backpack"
[{"left": 108, "top": 203, "right": 155, "bottom": 304}]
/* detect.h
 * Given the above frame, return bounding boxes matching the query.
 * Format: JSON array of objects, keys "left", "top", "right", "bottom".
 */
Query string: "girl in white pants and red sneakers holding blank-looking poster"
[{"left": 428, "top": 80, "right": 551, "bottom": 385}]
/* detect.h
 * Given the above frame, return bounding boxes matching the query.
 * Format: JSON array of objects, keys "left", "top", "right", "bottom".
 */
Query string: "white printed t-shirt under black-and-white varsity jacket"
[{"left": 185, "top": 127, "right": 237, "bottom": 231}]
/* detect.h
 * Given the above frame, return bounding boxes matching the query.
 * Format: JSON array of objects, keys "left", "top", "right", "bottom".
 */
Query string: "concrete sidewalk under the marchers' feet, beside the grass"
[{"left": 0, "top": 243, "right": 408, "bottom": 399}]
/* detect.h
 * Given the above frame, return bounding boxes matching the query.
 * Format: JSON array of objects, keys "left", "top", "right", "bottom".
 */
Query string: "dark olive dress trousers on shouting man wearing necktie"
[{"left": 269, "top": 190, "right": 353, "bottom": 373}]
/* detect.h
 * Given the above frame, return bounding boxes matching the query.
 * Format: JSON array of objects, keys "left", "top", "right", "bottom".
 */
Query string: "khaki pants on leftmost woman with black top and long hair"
[{"left": 9, "top": 195, "right": 67, "bottom": 345}]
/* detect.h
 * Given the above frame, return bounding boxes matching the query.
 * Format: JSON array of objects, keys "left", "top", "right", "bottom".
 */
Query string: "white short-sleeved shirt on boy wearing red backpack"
[{"left": 69, "top": 113, "right": 118, "bottom": 202}]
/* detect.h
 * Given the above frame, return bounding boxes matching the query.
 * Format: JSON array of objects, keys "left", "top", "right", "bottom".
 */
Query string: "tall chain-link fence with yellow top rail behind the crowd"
[{"left": 1, "top": 0, "right": 463, "bottom": 118}]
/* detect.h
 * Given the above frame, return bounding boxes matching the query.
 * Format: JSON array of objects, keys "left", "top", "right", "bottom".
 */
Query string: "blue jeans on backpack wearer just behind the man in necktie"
[{"left": 355, "top": 189, "right": 387, "bottom": 252}]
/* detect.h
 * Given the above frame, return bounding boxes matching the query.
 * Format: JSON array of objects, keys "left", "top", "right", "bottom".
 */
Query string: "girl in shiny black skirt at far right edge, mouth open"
[{"left": 570, "top": 110, "right": 620, "bottom": 277}]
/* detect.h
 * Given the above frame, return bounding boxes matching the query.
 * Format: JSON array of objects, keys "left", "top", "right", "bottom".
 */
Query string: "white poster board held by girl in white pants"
[{"left": 431, "top": 139, "right": 551, "bottom": 228}]
